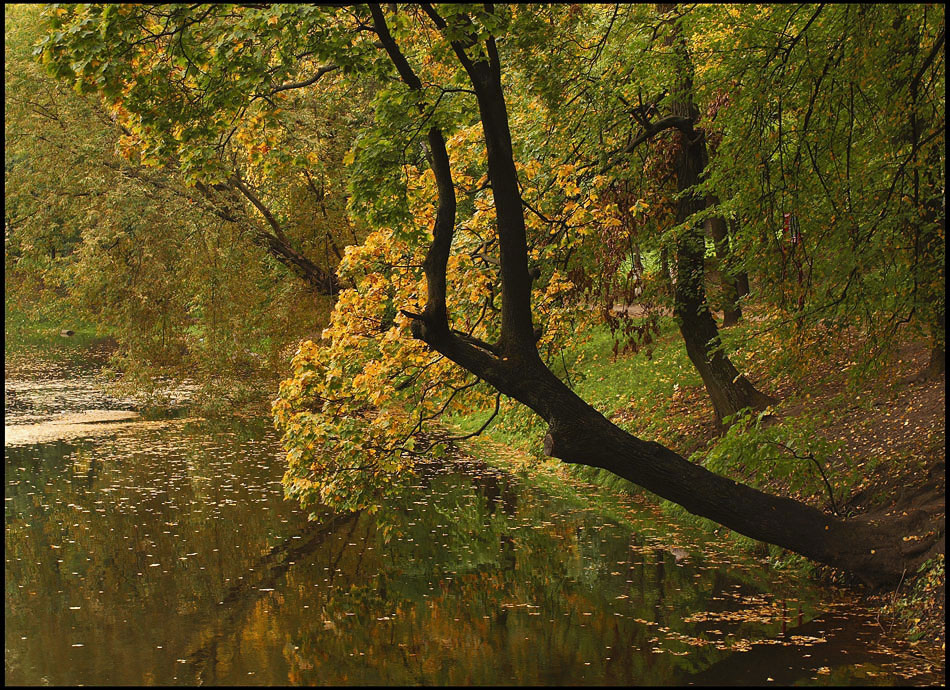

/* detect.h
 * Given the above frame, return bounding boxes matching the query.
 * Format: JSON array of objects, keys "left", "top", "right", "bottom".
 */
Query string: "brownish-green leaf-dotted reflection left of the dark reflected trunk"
[{"left": 5, "top": 424, "right": 316, "bottom": 683}]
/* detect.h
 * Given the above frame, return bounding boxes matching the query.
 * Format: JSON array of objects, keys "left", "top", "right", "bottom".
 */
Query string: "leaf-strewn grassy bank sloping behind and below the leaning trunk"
[{"left": 452, "top": 310, "right": 946, "bottom": 661}]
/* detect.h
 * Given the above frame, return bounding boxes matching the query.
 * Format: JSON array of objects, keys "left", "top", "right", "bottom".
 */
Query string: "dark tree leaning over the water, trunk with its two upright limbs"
[{"left": 371, "top": 6, "right": 942, "bottom": 585}]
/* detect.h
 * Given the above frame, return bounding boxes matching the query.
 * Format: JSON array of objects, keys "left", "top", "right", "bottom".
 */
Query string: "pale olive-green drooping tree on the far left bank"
[{"left": 4, "top": 5, "right": 346, "bottom": 374}]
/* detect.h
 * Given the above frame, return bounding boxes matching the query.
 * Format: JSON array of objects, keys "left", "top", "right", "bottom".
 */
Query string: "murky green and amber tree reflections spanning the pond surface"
[{"left": 8, "top": 420, "right": 872, "bottom": 684}]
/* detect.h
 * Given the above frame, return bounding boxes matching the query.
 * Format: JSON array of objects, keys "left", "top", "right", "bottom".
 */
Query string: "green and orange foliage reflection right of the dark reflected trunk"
[{"left": 272, "top": 460, "right": 792, "bottom": 684}]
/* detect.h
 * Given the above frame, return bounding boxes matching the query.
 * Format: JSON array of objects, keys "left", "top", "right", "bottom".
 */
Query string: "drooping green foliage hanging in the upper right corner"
[{"left": 696, "top": 4, "right": 946, "bottom": 372}]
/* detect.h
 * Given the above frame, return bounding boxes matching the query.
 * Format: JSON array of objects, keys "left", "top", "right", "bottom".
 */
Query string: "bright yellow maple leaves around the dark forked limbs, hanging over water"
[{"left": 273, "top": 127, "right": 607, "bottom": 509}]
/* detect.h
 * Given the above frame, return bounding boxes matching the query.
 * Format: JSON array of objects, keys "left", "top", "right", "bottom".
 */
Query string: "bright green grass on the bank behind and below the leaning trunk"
[{"left": 446, "top": 310, "right": 857, "bottom": 570}]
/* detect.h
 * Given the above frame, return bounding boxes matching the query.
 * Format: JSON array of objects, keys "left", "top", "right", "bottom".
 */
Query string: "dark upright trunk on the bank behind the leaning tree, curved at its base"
[{"left": 658, "top": 5, "right": 775, "bottom": 424}]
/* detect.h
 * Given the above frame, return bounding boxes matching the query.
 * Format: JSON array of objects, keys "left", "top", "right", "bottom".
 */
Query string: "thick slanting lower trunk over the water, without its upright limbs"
[{"left": 419, "top": 318, "right": 943, "bottom": 587}]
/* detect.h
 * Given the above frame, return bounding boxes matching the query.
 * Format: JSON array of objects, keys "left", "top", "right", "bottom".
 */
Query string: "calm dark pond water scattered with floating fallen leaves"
[{"left": 4, "top": 342, "right": 943, "bottom": 685}]
